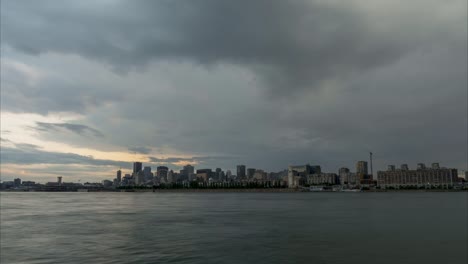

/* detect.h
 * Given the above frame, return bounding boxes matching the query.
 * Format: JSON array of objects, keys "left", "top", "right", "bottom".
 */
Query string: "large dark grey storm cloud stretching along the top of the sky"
[{"left": 2, "top": 0, "right": 424, "bottom": 95}]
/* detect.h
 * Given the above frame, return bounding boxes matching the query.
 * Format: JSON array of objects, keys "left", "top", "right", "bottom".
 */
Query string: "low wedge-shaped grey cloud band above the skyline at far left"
[{"left": 0, "top": 144, "right": 131, "bottom": 167}]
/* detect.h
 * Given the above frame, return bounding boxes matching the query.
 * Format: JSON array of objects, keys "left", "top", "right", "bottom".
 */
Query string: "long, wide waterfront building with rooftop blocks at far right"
[{"left": 377, "top": 163, "right": 458, "bottom": 188}]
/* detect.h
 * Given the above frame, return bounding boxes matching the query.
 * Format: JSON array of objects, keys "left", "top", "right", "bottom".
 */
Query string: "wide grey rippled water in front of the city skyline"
[{"left": 0, "top": 193, "right": 468, "bottom": 264}]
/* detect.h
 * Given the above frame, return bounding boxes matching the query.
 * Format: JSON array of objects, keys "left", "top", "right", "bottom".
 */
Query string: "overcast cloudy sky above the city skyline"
[{"left": 0, "top": 0, "right": 468, "bottom": 182}]
